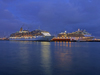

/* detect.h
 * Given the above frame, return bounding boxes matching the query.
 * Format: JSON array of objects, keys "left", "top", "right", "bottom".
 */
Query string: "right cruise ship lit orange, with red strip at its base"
[{"left": 52, "top": 29, "right": 94, "bottom": 41}]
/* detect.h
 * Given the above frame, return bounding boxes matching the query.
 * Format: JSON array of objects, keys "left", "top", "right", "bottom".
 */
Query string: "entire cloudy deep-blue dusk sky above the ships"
[{"left": 0, "top": 0, "right": 100, "bottom": 37}]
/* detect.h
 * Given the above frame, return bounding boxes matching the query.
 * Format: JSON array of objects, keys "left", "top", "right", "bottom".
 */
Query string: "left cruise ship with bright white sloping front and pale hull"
[{"left": 9, "top": 27, "right": 54, "bottom": 41}]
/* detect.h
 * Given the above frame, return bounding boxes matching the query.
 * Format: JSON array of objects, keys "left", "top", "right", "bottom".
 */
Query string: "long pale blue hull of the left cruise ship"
[{"left": 9, "top": 36, "right": 54, "bottom": 41}]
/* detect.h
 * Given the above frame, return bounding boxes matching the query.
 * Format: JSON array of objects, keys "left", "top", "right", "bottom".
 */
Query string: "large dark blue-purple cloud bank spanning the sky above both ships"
[{"left": 13, "top": 0, "right": 100, "bottom": 29}]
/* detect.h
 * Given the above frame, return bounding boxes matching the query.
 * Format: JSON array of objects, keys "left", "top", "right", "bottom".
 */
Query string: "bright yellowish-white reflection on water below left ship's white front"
[{"left": 41, "top": 42, "right": 52, "bottom": 75}]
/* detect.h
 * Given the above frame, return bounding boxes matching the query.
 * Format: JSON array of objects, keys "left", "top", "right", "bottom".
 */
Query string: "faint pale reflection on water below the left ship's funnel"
[{"left": 19, "top": 42, "right": 31, "bottom": 73}]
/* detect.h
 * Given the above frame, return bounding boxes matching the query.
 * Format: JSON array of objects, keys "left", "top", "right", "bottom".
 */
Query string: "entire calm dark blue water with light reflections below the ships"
[{"left": 0, "top": 41, "right": 100, "bottom": 75}]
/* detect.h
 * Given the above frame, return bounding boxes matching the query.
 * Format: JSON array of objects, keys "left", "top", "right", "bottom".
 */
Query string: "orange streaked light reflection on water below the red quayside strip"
[{"left": 54, "top": 42, "right": 72, "bottom": 75}]
